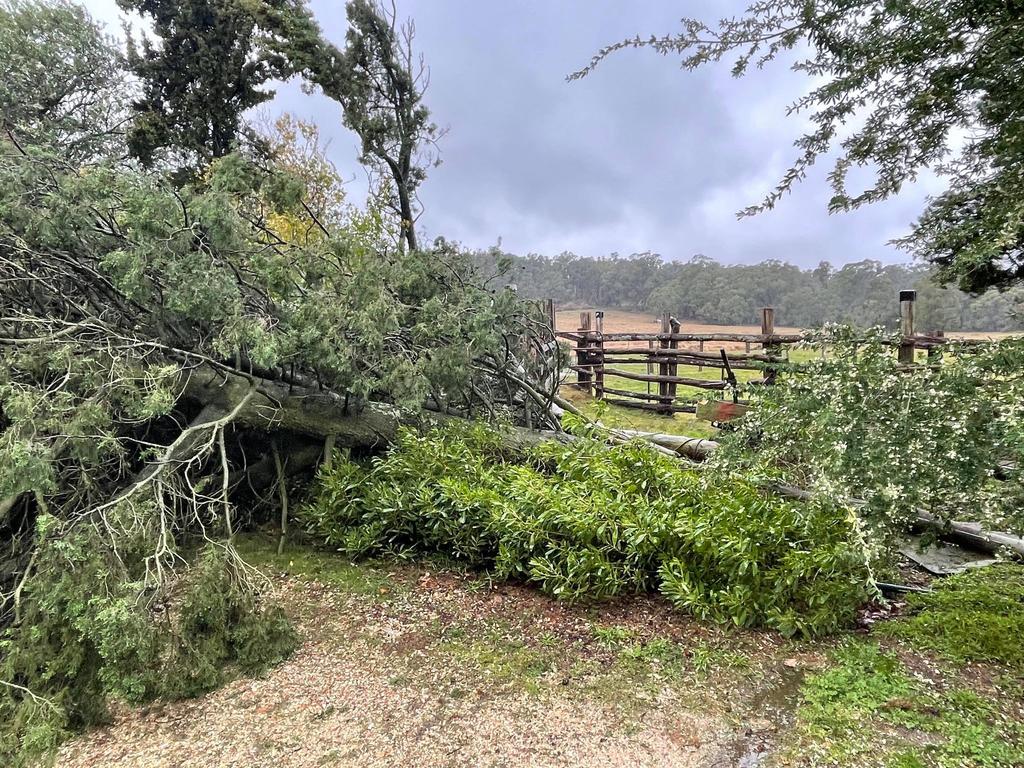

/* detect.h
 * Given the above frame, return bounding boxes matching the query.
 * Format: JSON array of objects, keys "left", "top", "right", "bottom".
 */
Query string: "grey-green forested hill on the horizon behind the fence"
[{"left": 475, "top": 249, "right": 1024, "bottom": 331}]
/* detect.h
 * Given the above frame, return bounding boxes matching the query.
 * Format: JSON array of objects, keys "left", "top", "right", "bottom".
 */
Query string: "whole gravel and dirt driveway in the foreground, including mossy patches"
[{"left": 58, "top": 548, "right": 806, "bottom": 768}]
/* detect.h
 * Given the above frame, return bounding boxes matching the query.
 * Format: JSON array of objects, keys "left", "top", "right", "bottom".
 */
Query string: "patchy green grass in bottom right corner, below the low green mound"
[{"left": 798, "top": 639, "right": 1024, "bottom": 768}]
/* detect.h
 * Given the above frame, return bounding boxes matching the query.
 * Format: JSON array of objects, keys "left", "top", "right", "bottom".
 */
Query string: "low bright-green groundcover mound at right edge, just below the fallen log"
[{"left": 877, "top": 564, "right": 1024, "bottom": 673}]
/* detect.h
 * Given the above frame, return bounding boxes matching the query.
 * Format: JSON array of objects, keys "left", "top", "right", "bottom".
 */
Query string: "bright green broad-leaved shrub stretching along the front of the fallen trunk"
[{"left": 301, "top": 426, "right": 868, "bottom": 634}]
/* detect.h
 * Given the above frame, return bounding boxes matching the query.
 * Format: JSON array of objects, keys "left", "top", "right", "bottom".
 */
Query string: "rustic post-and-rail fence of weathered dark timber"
[{"left": 545, "top": 291, "right": 948, "bottom": 421}]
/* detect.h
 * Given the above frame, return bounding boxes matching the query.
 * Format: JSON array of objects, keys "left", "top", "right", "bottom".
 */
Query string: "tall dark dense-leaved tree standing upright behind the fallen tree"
[{"left": 118, "top": 0, "right": 305, "bottom": 167}]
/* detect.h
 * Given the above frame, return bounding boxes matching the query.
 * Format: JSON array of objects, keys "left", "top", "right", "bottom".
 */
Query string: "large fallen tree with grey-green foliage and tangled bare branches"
[{"left": 0, "top": 3, "right": 556, "bottom": 760}]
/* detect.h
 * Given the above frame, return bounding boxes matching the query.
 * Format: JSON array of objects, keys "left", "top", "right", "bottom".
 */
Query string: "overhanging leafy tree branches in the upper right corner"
[{"left": 570, "top": 0, "right": 1024, "bottom": 292}]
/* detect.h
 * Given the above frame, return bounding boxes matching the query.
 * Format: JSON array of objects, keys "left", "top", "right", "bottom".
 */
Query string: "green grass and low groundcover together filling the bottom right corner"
[{"left": 795, "top": 563, "right": 1024, "bottom": 768}]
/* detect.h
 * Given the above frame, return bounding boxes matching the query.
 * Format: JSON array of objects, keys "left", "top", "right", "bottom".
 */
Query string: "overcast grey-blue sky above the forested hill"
[{"left": 79, "top": 0, "right": 935, "bottom": 266}]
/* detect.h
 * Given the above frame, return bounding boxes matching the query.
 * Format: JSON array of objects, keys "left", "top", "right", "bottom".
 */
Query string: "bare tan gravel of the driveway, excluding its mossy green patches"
[{"left": 58, "top": 561, "right": 786, "bottom": 768}]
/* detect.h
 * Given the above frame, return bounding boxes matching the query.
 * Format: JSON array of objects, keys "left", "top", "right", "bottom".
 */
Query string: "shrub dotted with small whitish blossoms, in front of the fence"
[{"left": 714, "top": 328, "right": 1024, "bottom": 547}]
